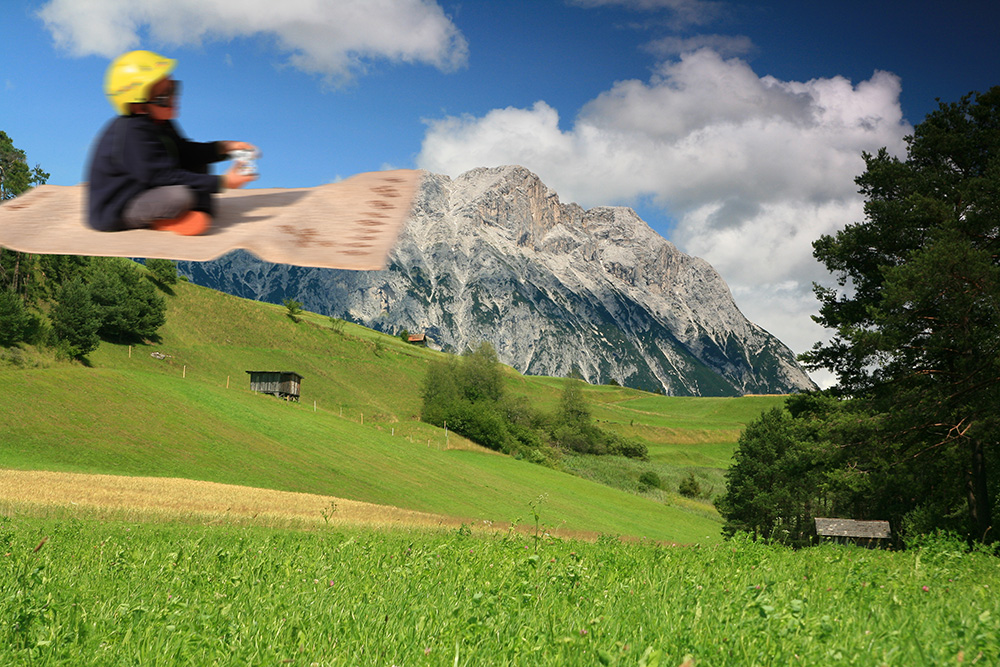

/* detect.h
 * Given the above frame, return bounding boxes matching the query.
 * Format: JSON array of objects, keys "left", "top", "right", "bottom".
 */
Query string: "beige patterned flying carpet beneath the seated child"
[{"left": 0, "top": 169, "right": 423, "bottom": 270}]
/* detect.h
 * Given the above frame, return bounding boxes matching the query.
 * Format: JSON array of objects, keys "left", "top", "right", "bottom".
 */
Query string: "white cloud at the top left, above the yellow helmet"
[{"left": 39, "top": 0, "right": 468, "bottom": 80}]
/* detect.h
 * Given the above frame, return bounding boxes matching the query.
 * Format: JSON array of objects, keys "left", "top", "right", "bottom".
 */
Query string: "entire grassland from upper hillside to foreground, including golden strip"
[{"left": 0, "top": 270, "right": 1000, "bottom": 667}]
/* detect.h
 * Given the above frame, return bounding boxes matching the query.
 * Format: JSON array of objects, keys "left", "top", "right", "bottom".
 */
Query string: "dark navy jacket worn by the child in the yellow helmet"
[{"left": 87, "top": 116, "right": 225, "bottom": 231}]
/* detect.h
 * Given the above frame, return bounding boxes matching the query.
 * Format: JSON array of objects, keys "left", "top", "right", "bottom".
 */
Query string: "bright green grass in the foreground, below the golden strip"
[{"left": 0, "top": 508, "right": 1000, "bottom": 667}]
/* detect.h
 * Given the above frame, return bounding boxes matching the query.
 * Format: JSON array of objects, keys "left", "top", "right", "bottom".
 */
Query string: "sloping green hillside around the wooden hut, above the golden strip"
[{"left": 0, "top": 274, "right": 781, "bottom": 543}]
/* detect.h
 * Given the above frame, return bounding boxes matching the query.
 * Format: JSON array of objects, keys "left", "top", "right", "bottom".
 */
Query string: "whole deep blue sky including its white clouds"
[{"left": 0, "top": 0, "right": 1000, "bottom": 381}]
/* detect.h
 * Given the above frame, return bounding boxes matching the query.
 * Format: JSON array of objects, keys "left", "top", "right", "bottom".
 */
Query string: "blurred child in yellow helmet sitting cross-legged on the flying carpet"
[{"left": 88, "top": 51, "right": 256, "bottom": 236}]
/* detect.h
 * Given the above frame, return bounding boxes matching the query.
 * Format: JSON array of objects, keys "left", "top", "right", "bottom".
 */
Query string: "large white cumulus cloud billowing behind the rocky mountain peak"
[{"left": 418, "top": 49, "right": 912, "bottom": 370}]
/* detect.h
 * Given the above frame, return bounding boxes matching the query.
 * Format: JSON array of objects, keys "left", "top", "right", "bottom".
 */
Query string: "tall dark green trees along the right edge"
[{"left": 726, "top": 87, "right": 1000, "bottom": 541}]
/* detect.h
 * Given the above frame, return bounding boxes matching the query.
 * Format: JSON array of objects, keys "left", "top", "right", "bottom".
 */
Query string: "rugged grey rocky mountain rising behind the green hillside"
[{"left": 178, "top": 167, "right": 815, "bottom": 396}]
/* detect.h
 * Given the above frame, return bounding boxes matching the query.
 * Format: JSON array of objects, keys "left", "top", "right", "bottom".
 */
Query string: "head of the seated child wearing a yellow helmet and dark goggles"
[{"left": 104, "top": 51, "right": 179, "bottom": 119}]
